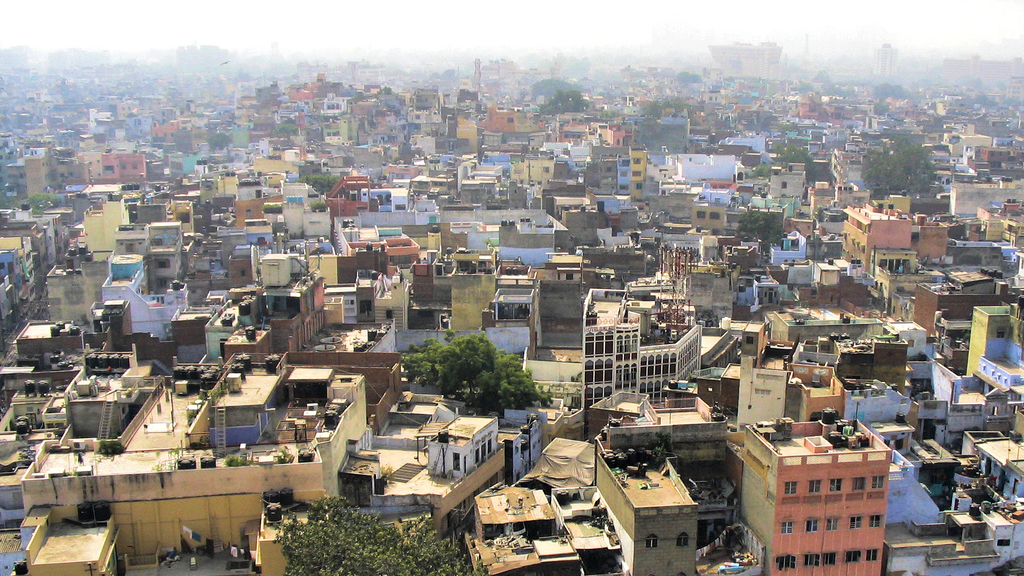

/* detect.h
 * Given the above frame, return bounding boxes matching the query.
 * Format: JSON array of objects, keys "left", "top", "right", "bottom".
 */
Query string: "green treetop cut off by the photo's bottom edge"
[{"left": 278, "top": 497, "right": 483, "bottom": 576}]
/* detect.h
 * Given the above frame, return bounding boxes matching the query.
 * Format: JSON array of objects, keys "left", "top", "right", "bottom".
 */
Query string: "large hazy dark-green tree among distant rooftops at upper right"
[{"left": 863, "top": 138, "right": 935, "bottom": 195}]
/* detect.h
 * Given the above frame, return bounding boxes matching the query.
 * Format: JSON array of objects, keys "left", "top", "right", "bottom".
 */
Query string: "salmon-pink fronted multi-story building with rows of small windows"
[{"left": 740, "top": 411, "right": 892, "bottom": 576}]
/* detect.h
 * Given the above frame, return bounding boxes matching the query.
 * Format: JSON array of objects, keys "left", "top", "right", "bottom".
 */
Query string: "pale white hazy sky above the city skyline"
[{"left": 6, "top": 0, "right": 1024, "bottom": 59}]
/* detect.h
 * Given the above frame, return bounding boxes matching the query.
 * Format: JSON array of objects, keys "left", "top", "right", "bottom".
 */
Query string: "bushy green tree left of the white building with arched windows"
[{"left": 402, "top": 334, "right": 551, "bottom": 413}]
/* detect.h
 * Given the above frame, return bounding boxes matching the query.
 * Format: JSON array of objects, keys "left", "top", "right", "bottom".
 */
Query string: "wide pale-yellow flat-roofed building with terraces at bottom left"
[{"left": 22, "top": 359, "right": 367, "bottom": 575}]
